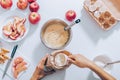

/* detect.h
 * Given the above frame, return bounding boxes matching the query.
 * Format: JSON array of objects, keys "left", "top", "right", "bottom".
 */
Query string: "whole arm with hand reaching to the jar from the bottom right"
[{"left": 69, "top": 54, "right": 116, "bottom": 80}]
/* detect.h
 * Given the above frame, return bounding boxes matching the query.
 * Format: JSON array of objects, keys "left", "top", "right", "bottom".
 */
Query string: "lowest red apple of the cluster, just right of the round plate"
[{"left": 29, "top": 12, "right": 40, "bottom": 24}]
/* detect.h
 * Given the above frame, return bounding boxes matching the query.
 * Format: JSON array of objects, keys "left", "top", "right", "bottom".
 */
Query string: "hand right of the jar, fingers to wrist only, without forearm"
[{"left": 69, "top": 54, "right": 92, "bottom": 68}]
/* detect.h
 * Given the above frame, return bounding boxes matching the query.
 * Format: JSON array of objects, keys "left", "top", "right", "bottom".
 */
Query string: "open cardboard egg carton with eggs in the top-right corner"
[{"left": 84, "top": 0, "right": 120, "bottom": 30}]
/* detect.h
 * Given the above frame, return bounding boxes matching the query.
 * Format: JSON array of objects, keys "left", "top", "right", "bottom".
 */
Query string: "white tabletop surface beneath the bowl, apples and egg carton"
[{"left": 0, "top": 0, "right": 120, "bottom": 80}]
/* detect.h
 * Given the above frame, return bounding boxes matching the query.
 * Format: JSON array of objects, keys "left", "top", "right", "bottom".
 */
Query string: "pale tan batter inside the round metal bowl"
[{"left": 43, "top": 23, "right": 69, "bottom": 48}]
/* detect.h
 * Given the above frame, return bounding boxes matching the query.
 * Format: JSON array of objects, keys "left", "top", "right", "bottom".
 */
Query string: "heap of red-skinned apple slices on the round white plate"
[{"left": 3, "top": 17, "right": 26, "bottom": 40}]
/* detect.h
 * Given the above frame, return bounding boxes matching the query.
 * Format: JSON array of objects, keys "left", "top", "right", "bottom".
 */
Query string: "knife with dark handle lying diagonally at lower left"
[{"left": 2, "top": 45, "right": 18, "bottom": 79}]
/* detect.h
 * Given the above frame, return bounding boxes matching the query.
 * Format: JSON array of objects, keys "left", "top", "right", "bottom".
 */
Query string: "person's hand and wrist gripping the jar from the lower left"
[{"left": 30, "top": 55, "right": 48, "bottom": 80}]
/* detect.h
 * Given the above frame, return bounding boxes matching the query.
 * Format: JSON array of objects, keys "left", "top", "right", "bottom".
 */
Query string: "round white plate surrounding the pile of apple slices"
[{"left": 0, "top": 10, "right": 30, "bottom": 42}]
